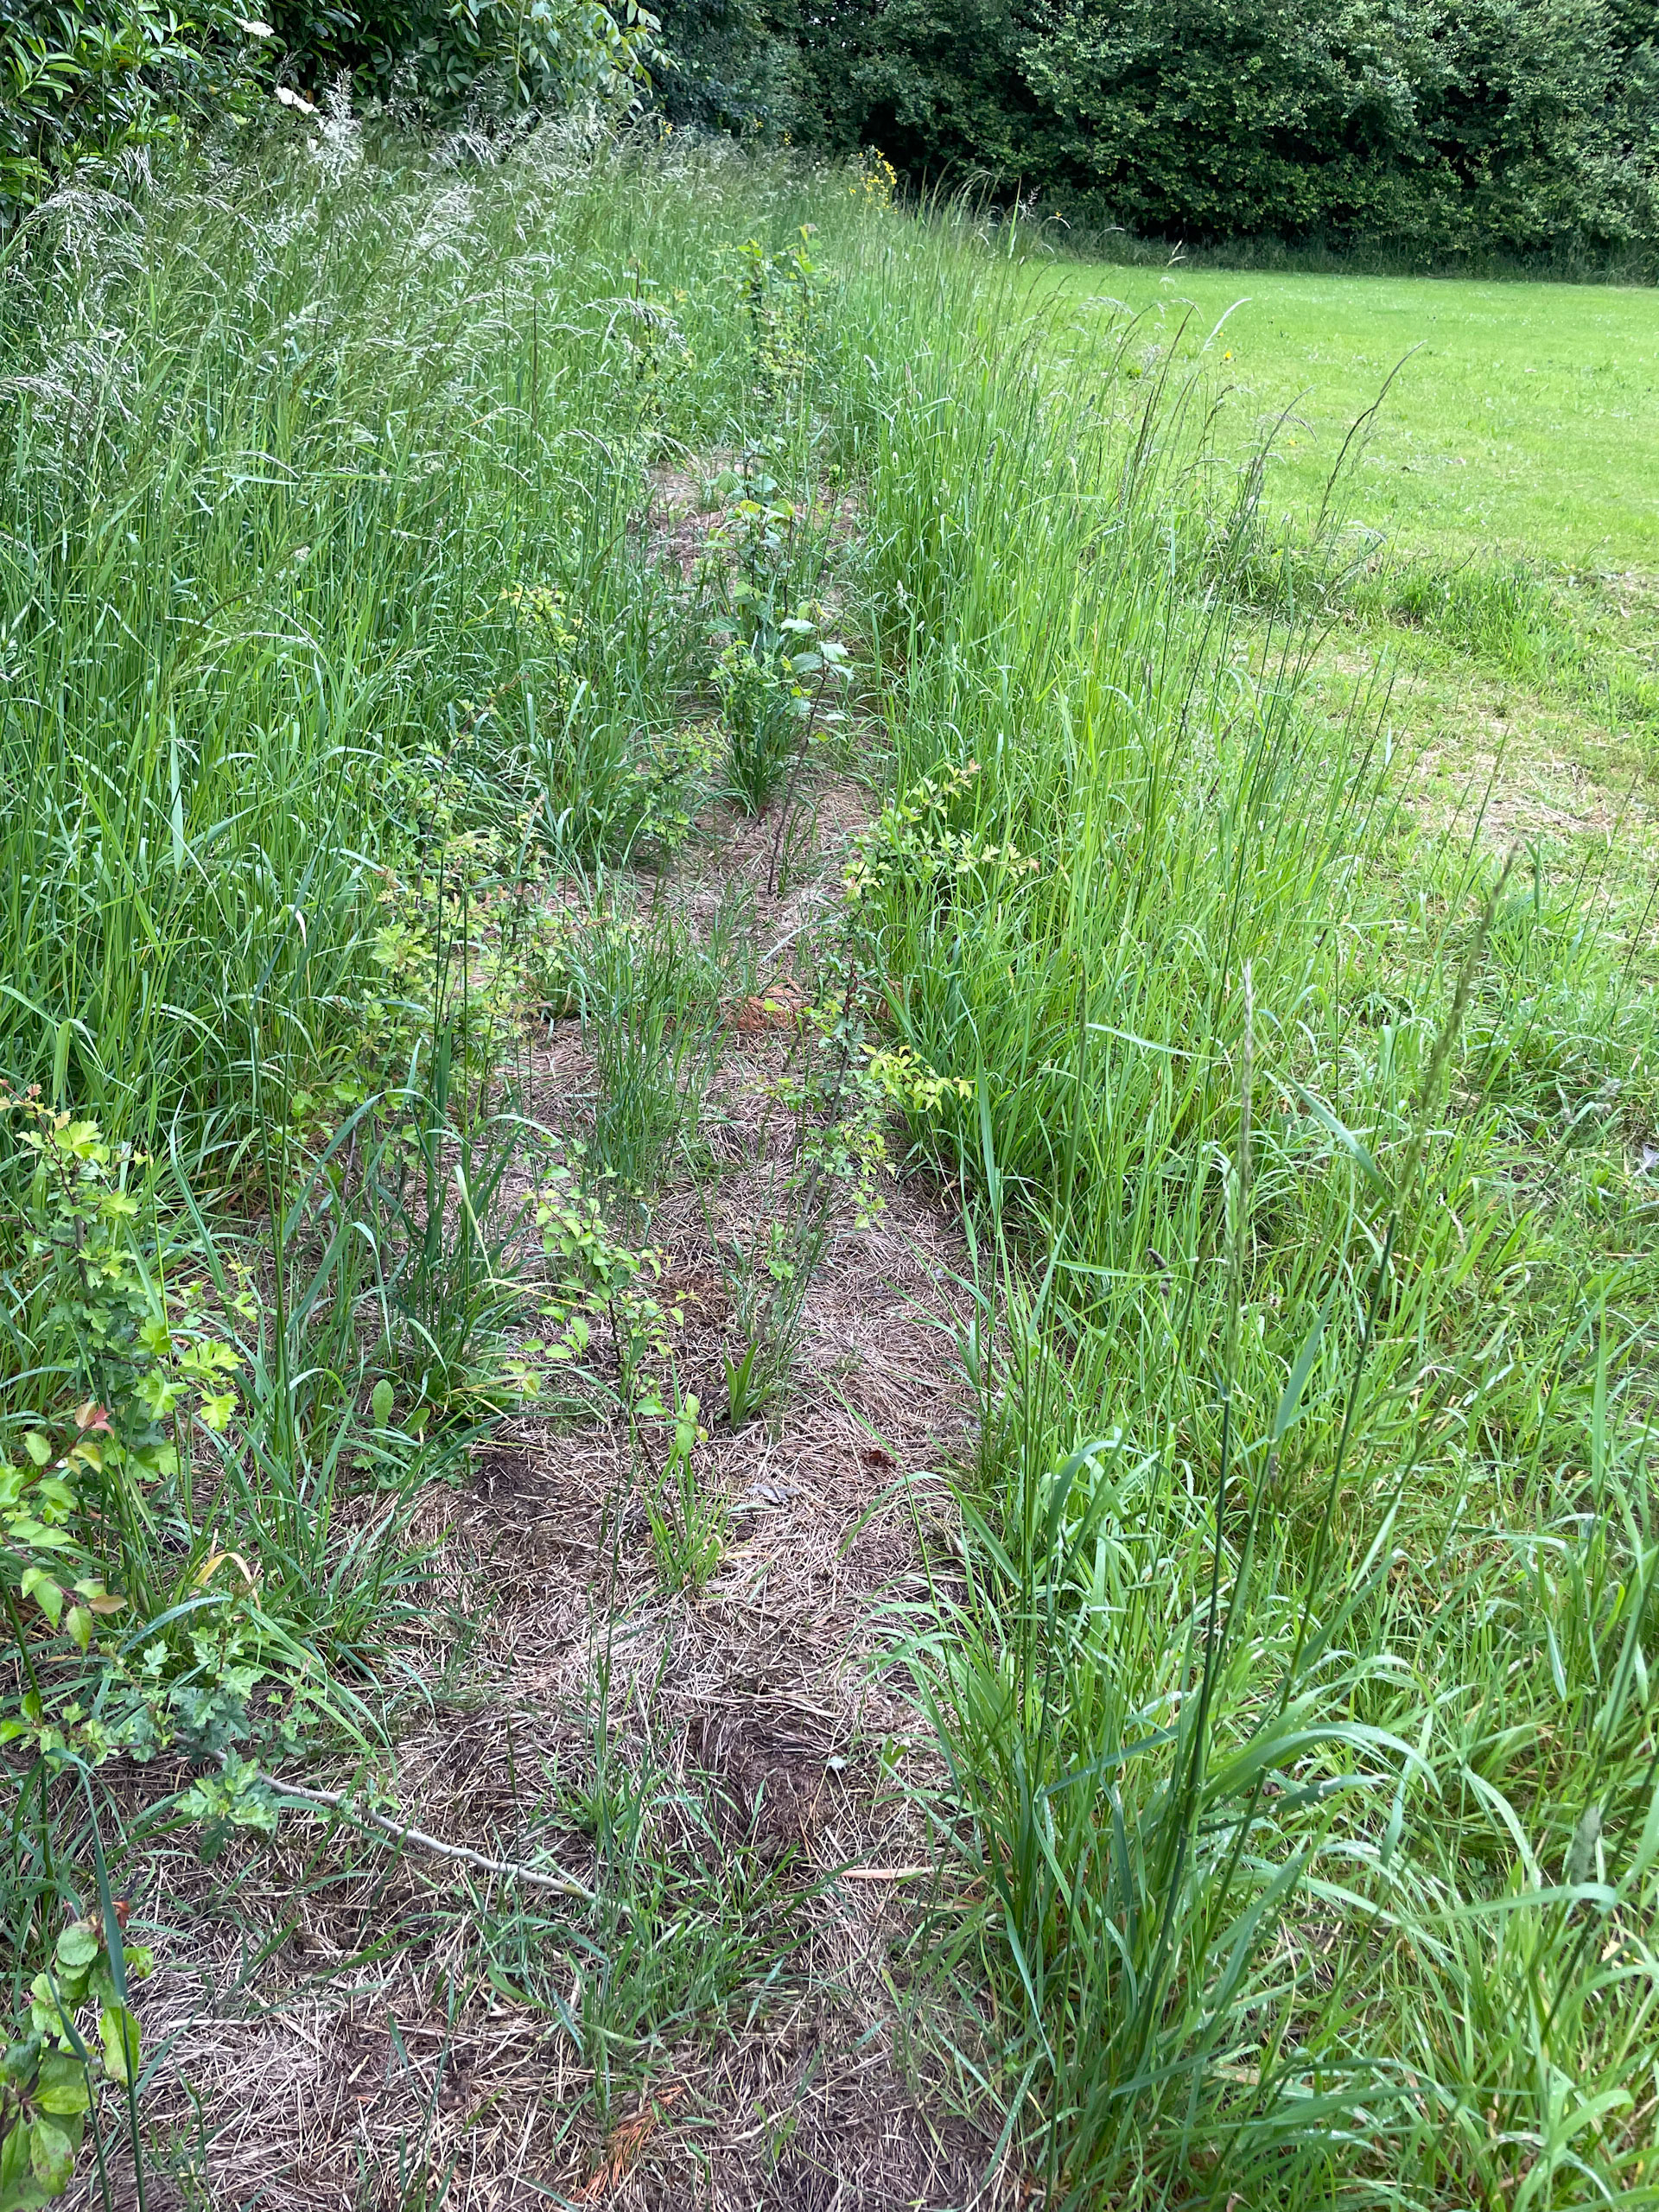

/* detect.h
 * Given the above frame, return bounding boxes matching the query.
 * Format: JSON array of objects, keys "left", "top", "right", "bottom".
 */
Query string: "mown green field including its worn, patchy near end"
[{"left": 1052, "top": 268, "right": 1659, "bottom": 796}]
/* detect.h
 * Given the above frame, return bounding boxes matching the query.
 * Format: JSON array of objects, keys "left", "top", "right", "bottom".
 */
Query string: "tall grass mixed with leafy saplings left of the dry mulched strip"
[{"left": 0, "top": 126, "right": 889, "bottom": 2123}]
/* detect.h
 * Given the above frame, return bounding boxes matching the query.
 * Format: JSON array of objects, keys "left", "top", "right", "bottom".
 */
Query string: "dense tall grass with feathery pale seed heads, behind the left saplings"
[{"left": 0, "top": 142, "right": 849, "bottom": 1159}]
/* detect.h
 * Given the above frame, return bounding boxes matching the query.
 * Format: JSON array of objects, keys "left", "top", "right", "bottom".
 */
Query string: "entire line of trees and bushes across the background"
[{"left": 0, "top": 0, "right": 1659, "bottom": 268}]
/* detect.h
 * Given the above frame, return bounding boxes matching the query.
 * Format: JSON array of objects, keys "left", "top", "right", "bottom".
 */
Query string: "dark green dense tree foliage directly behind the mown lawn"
[{"left": 666, "top": 0, "right": 1659, "bottom": 254}]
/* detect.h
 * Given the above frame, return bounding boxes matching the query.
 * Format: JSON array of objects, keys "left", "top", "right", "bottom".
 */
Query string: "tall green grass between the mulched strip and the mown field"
[{"left": 844, "top": 254, "right": 1659, "bottom": 2205}]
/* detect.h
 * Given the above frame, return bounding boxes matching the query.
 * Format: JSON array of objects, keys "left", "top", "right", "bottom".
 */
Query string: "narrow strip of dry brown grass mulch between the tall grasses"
[{"left": 113, "top": 785, "right": 1018, "bottom": 2212}]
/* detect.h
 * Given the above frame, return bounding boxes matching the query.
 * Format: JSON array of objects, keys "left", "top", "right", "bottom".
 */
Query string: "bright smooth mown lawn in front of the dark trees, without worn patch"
[{"left": 1062, "top": 268, "right": 1659, "bottom": 570}]
